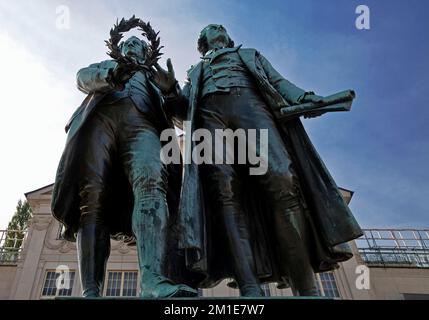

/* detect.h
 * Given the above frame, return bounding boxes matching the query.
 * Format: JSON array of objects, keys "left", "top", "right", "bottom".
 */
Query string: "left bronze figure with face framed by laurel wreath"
[{"left": 52, "top": 17, "right": 197, "bottom": 298}]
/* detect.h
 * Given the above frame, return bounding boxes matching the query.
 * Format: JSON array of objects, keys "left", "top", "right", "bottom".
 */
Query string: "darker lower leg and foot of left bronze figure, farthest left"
[{"left": 77, "top": 222, "right": 110, "bottom": 298}]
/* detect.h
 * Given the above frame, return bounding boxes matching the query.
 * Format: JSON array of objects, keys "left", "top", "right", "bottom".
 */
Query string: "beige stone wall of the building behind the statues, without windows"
[{"left": 0, "top": 187, "right": 429, "bottom": 300}]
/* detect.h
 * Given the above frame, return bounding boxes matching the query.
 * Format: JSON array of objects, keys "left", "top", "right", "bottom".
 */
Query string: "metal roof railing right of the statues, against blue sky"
[{"left": 356, "top": 229, "right": 429, "bottom": 268}]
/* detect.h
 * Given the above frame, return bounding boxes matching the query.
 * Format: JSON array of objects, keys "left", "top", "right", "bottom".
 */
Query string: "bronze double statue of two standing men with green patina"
[{"left": 52, "top": 17, "right": 362, "bottom": 298}]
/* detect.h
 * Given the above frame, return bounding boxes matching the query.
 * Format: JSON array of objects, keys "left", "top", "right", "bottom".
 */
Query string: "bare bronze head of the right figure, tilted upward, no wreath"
[{"left": 198, "top": 24, "right": 234, "bottom": 55}]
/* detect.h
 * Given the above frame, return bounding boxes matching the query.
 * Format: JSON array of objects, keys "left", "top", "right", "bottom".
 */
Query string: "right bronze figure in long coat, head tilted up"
[{"left": 156, "top": 24, "right": 362, "bottom": 296}]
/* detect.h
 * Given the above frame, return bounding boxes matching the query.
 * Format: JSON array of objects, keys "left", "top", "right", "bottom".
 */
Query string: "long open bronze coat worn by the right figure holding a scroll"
[{"left": 166, "top": 49, "right": 362, "bottom": 287}]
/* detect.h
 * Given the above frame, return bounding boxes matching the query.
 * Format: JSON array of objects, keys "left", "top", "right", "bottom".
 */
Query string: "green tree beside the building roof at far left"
[{"left": 0, "top": 200, "right": 32, "bottom": 262}]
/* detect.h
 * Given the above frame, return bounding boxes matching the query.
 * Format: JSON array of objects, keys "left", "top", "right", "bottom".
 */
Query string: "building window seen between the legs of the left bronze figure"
[{"left": 106, "top": 271, "right": 137, "bottom": 297}]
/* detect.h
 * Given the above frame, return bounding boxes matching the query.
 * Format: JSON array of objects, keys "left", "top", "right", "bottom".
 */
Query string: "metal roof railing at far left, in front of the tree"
[{"left": 0, "top": 230, "right": 27, "bottom": 265}]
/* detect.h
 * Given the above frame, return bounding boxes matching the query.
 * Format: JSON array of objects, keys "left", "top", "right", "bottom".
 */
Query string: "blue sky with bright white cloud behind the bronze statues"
[{"left": 0, "top": 0, "right": 429, "bottom": 228}]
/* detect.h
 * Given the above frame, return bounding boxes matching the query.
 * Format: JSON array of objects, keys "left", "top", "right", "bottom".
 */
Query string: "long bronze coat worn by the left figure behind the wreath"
[{"left": 51, "top": 60, "right": 182, "bottom": 245}]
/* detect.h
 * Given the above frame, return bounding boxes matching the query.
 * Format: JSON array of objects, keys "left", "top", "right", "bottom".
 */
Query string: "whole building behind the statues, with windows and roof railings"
[{"left": 0, "top": 185, "right": 429, "bottom": 300}]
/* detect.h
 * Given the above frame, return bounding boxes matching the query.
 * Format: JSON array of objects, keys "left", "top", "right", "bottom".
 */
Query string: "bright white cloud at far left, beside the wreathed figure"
[{"left": 0, "top": 33, "right": 76, "bottom": 228}]
